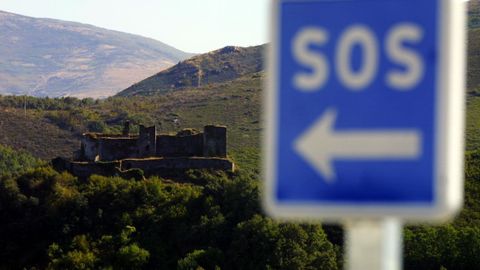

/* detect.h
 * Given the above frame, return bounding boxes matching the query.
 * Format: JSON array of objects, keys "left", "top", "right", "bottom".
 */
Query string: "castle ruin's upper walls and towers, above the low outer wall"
[{"left": 75, "top": 124, "right": 227, "bottom": 161}]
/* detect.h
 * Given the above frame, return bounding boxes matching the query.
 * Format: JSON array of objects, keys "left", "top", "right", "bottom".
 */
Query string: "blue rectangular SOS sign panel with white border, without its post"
[{"left": 264, "top": 0, "right": 464, "bottom": 219}]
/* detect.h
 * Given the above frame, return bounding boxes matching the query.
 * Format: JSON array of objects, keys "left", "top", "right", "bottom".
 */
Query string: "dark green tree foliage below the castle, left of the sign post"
[{"left": 0, "top": 167, "right": 337, "bottom": 269}]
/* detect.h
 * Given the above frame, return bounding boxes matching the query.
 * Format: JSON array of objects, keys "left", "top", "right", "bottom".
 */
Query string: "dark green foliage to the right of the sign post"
[{"left": 404, "top": 151, "right": 480, "bottom": 270}]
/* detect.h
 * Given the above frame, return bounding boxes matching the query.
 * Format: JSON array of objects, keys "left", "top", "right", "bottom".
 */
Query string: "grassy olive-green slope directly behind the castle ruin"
[{"left": 0, "top": 73, "right": 263, "bottom": 169}]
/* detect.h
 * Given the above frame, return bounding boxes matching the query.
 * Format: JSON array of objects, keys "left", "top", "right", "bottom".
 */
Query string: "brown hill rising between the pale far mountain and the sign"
[{"left": 117, "top": 45, "right": 265, "bottom": 96}]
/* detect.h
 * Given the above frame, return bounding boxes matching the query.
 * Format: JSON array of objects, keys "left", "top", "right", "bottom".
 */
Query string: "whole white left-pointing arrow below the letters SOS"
[{"left": 294, "top": 108, "right": 421, "bottom": 182}]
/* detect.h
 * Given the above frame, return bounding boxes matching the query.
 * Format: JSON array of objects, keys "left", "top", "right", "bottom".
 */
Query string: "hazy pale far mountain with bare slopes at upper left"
[{"left": 0, "top": 11, "right": 192, "bottom": 97}]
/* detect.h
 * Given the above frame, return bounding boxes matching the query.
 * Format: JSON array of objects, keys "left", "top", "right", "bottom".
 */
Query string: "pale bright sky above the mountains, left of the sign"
[{"left": 0, "top": 0, "right": 270, "bottom": 53}]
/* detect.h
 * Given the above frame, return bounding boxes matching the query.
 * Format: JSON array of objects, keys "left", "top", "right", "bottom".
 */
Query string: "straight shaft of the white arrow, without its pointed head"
[{"left": 327, "top": 130, "right": 421, "bottom": 159}]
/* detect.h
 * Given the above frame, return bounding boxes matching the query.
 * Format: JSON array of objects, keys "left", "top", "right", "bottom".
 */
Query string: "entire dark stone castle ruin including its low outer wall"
[{"left": 53, "top": 122, "right": 234, "bottom": 178}]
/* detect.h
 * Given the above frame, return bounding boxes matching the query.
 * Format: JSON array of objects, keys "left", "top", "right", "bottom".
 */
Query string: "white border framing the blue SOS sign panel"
[{"left": 262, "top": 0, "right": 466, "bottom": 221}]
